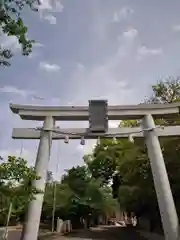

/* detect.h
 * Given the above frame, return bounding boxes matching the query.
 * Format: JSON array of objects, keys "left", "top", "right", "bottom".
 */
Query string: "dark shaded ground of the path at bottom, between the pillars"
[{"left": 66, "top": 226, "right": 146, "bottom": 240}]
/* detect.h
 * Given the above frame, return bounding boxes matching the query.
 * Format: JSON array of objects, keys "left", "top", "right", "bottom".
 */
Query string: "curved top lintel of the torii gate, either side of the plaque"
[{"left": 10, "top": 103, "right": 180, "bottom": 121}]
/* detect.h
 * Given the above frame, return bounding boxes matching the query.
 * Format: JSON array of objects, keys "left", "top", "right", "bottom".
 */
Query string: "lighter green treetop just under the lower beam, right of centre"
[{"left": 84, "top": 139, "right": 137, "bottom": 184}]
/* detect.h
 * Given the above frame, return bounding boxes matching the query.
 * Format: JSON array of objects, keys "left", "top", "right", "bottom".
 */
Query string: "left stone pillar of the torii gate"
[{"left": 21, "top": 117, "right": 54, "bottom": 240}]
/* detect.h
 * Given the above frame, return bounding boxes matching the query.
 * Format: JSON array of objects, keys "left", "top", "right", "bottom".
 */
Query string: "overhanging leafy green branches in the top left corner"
[{"left": 0, "top": 0, "right": 40, "bottom": 66}]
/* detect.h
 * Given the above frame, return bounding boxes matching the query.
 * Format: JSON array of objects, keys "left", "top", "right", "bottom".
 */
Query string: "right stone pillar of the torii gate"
[{"left": 142, "top": 115, "right": 179, "bottom": 240}]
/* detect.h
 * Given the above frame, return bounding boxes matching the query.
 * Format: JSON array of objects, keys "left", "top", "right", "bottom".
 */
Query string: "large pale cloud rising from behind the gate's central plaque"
[{"left": 68, "top": 28, "right": 138, "bottom": 104}]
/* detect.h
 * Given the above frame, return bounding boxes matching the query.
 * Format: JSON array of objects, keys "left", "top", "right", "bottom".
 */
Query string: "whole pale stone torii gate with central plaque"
[{"left": 10, "top": 100, "right": 180, "bottom": 240}]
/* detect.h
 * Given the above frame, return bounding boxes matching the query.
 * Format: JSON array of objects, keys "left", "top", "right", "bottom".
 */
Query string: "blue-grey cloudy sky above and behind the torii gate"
[{"left": 0, "top": 0, "right": 180, "bottom": 179}]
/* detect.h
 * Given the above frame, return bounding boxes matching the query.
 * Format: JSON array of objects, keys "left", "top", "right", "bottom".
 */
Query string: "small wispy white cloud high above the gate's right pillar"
[{"left": 137, "top": 46, "right": 163, "bottom": 60}]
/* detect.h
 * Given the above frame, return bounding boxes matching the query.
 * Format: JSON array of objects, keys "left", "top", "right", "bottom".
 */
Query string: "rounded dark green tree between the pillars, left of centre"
[{"left": 55, "top": 166, "right": 117, "bottom": 227}]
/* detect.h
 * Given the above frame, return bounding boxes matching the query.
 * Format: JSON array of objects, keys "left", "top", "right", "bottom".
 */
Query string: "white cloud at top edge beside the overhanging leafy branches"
[{"left": 38, "top": 0, "right": 64, "bottom": 24}]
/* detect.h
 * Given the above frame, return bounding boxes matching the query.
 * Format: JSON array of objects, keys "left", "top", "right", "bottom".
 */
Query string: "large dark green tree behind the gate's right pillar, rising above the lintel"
[{"left": 118, "top": 77, "right": 180, "bottom": 229}]
